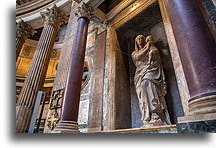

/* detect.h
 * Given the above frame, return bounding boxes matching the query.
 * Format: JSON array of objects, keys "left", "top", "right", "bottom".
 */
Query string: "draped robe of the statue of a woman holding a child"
[{"left": 132, "top": 48, "right": 170, "bottom": 125}]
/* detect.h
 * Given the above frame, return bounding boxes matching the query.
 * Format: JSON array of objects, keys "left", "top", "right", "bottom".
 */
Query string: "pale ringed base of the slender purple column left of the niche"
[{"left": 51, "top": 121, "right": 80, "bottom": 133}]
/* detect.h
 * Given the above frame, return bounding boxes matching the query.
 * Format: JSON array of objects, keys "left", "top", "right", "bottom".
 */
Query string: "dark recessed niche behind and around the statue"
[{"left": 116, "top": 2, "right": 184, "bottom": 128}]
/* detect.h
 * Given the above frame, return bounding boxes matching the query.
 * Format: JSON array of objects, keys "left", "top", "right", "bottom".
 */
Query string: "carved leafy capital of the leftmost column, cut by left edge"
[{"left": 16, "top": 20, "right": 36, "bottom": 38}]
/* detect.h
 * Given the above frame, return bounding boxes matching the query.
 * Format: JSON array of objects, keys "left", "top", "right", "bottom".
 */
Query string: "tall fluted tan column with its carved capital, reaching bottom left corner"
[{"left": 16, "top": 5, "right": 67, "bottom": 133}]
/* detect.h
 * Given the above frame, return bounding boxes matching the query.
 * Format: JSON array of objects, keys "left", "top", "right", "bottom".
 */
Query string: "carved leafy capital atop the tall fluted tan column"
[{"left": 40, "top": 5, "right": 68, "bottom": 26}]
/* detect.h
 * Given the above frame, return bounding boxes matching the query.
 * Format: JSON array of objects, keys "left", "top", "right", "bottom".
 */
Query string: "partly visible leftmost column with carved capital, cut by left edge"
[{"left": 16, "top": 20, "right": 36, "bottom": 60}]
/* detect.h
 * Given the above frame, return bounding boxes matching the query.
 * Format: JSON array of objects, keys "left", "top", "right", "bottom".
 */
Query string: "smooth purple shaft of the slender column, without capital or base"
[{"left": 61, "top": 18, "right": 88, "bottom": 122}]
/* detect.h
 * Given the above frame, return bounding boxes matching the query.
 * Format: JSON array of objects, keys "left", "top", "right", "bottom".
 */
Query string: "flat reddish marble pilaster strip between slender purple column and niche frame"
[{"left": 88, "top": 31, "right": 106, "bottom": 131}]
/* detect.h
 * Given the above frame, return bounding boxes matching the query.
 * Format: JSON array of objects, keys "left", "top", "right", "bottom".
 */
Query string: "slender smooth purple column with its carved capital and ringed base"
[{"left": 53, "top": 3, "right": 92, "bottom": 133}]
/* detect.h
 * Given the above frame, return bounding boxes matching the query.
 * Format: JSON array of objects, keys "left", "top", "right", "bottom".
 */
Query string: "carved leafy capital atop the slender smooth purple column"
[{"left": 75, "top": 2, "right": 94, "bottom": 20}]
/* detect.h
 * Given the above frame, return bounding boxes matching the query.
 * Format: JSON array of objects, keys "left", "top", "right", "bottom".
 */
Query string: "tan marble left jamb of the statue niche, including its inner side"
[{"left": 102, "top": 27, "right": 131, "bottom": 130}]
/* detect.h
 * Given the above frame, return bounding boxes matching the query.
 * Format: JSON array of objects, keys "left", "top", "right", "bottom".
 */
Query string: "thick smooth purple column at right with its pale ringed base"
[{"left": 164, "top": 0, "right": 216, "bottom": 115}]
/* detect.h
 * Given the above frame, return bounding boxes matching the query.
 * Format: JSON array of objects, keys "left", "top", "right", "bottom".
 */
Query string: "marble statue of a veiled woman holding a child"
[{"left": 131, "top": 35, "right": 171, "bottom": 127}]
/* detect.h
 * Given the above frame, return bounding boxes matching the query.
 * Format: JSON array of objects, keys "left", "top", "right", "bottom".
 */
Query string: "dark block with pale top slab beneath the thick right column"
[{"left": 176, "top": 113, "right": 216, "bottom": 133}]
